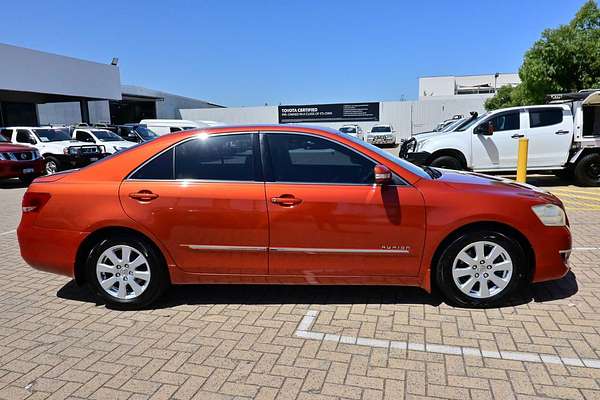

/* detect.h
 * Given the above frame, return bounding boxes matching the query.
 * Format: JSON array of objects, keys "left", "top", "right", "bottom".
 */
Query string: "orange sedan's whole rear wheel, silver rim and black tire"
[{"left": 86, "top": 234, "right": 169, "bottom": 309}]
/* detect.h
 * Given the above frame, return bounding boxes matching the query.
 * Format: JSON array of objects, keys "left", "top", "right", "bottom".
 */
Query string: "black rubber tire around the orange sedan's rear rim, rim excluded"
[{"left": 85, "top": 234, "right": 170, "bottom": 310}]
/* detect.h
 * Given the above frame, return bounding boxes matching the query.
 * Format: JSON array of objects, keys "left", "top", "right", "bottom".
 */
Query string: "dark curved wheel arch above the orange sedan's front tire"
[{"left": 427, "top": 221, "right": 535, "bottom": 288}]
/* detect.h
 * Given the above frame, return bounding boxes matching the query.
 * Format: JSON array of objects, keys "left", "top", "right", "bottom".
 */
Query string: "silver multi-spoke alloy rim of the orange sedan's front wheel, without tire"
[{"left": 452, "top": 241, "right": 513, "bottom": 299}]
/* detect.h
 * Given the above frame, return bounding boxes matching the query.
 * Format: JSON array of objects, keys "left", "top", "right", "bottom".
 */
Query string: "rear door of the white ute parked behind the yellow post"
[{"left": 525, "top": 106, "right": 573, "bottom": 167}]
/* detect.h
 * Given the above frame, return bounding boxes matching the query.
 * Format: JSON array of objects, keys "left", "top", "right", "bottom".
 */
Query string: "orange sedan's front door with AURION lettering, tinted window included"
[{"left": 263, "top": 133, "right": 425, "bottom": 276}]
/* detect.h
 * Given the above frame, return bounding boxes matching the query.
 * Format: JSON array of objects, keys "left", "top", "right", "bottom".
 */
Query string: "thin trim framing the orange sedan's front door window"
[{"left": 259, "top": 130, "right": 410, "bottom": 186}]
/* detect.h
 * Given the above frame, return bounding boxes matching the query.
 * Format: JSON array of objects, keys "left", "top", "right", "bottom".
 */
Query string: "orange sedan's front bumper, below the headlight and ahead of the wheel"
[{"left": 529, "top": 227, "right": 571, "bottom": 282}]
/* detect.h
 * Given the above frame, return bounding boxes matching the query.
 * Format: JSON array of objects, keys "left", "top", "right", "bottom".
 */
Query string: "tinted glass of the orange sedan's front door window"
[{"left": 267, "top": 133, "right": 375, "bottom": 184}]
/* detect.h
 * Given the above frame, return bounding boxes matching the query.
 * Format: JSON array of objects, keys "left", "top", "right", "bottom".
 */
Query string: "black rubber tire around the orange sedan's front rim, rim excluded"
[{"left": 435, "top": 230, "right": 528, "bottom": 308}]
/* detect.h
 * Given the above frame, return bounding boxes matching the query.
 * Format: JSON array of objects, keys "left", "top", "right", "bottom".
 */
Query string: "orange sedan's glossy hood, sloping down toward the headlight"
[{"left": 436, "top": 168, "right": 562, "bottom": 204}]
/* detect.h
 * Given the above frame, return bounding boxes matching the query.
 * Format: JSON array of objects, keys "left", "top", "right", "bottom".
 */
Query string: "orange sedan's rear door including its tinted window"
[{"left": 120, "top": 133, "right": 268, "bottom": 275}]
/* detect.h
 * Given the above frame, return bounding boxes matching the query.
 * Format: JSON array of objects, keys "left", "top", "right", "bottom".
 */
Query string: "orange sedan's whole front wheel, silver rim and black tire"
[{"left": 436, "top": 230, "right": 527, "bottom": 307}]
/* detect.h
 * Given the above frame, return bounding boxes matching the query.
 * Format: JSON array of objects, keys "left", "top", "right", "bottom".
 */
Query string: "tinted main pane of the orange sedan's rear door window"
[{"left": 175, "top": 134, "right": 256, "bottom": 181}]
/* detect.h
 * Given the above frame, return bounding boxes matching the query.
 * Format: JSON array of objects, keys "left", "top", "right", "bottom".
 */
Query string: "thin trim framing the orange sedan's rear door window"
[{"left": 123, "top": 131, "right": 265, "bottom": 184}]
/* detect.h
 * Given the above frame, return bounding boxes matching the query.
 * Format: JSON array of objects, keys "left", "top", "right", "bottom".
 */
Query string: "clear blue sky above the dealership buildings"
[{"left": 0, "top": 0, "right": 584, "bottom": 106}]
